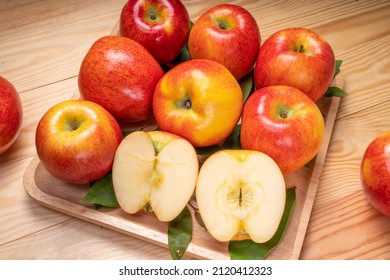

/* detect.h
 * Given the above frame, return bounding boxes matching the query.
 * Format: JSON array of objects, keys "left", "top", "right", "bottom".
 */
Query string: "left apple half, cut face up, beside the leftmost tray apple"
[{"left": 112, "top": 131, "right": 199, "bottom": 222}]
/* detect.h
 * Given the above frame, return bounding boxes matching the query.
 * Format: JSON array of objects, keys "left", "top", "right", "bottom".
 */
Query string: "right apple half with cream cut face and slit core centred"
[{"left": 196, "top": 150, "right": 286, "bottom": 243}]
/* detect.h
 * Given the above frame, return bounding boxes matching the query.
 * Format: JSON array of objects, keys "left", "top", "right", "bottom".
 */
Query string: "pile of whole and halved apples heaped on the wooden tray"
[{"left": 36, "top": 0, "right": 335, "bottom": 242}]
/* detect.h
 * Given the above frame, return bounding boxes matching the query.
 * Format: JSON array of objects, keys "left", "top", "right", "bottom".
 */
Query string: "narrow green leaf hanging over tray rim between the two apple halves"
[{"left": 168, "top": 206, "right": 192, "bottom": 260}]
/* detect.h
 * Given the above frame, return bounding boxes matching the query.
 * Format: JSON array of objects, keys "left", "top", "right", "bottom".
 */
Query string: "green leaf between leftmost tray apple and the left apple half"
[{"left": 80, "top": 173, "right": 119, "bottom": 208}]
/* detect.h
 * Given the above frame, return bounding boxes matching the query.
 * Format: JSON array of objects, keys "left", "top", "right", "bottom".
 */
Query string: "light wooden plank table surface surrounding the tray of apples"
[{"left": 0, "top": 0, "right": 390, "bottom": 260}]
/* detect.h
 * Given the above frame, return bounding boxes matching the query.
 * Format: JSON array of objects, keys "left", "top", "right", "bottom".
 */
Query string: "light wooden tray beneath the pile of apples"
[{"left": 23, "top": 73, "right": 343, "bottom": 259}]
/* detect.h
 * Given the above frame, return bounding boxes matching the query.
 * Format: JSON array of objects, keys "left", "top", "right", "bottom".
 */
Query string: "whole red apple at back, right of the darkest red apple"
[{"left": 188, "top": 4, "right": 261, "bottom": 80}]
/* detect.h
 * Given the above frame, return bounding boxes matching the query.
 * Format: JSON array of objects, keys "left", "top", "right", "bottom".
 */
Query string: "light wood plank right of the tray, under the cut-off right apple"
[{"left": 301, "top": 101, "right": 390, "bottom": 259}]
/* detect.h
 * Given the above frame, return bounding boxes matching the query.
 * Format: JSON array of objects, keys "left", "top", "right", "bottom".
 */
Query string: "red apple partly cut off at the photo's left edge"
[{"left": 0, "top": 76, "right": 23, "bottom": 155}]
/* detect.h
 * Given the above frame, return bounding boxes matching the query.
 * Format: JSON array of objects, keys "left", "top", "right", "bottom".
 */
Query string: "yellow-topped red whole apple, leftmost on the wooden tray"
[{"left": 35, "top": 100, "right": 122, "bottom": 184}]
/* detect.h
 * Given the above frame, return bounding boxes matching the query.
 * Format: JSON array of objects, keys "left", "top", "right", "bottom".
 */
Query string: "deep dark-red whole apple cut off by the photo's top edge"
[{"left": 119, "top": 0, "right": 190, "bottom": 64}]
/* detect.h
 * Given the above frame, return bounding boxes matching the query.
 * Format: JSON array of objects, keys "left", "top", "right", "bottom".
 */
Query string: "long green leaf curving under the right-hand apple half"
[{"left": 229, "top": 187, "right": 295, "bottom": 260}]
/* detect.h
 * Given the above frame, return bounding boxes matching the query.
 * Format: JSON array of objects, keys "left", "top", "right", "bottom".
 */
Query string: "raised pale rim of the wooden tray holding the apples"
[{"left": 23, "top": 88, "right": 343, "bottom": 260}]
